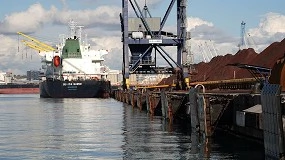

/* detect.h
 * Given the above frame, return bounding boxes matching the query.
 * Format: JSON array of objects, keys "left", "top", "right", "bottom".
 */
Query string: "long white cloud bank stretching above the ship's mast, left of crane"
[{"left": 0, "top": 1, "right": 121, "bottom": 34}]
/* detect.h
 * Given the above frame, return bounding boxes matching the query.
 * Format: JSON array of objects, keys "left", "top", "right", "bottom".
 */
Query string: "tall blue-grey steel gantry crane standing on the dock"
[{"left": 120, "top": 0, "right": 189, "bottom": 89}]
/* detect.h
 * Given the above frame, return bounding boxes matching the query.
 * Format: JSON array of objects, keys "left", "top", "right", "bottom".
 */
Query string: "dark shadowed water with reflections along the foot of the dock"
[{"left": 122, "top": 101, "right": 263, "bottom": 159}]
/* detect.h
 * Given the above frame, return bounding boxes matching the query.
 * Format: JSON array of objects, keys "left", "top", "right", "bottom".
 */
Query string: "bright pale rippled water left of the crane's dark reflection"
[{"left": 0, "top": 97, "right": 123, "bottom": 159}]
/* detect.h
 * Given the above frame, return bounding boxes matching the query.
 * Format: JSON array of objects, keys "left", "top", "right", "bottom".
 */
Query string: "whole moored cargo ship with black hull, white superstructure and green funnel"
[{"left": 39, "top": 21, "right": 111, "bottom": 98}]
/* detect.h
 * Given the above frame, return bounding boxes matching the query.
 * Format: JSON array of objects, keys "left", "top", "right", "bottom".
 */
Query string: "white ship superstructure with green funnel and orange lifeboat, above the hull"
[{"left": 42, "top": 21, "right": 109, "bottom": 80}]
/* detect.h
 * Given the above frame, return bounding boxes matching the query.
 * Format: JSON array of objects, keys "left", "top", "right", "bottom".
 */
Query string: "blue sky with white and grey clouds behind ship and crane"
[{"left": 0, "top": 0, "right": 285, "bottom": 74}]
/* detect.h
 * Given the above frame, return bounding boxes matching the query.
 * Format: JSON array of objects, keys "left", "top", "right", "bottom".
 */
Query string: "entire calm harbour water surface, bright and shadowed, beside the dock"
[{"left": 0, "top": 95, "right": 263, "bottom": 160}]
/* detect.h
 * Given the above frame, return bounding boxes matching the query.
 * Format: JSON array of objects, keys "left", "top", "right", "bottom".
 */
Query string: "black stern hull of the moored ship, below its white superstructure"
[{"left": 40, "top": 80, "right": 111, "bottom": 98}]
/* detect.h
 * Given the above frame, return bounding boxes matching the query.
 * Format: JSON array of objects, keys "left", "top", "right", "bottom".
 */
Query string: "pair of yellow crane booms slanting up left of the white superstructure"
[{"left": 17, "top": 32, "right": 56, "bottom": 52}]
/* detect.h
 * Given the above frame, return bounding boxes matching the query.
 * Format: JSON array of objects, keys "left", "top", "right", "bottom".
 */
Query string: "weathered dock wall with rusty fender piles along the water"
[{"left": 113, "top": 84, "right": 284, "bottom": 157}]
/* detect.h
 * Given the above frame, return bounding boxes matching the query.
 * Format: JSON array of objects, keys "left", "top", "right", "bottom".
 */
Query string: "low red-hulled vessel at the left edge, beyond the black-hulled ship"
[{"left": 0, "top": 72, "right": 40, "bottom": 94}]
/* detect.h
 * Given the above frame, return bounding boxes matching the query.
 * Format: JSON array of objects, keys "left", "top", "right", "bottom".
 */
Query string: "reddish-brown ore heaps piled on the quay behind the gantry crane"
[{"left": 156, "top": 39, "right": 285, "bottom": 84}]
